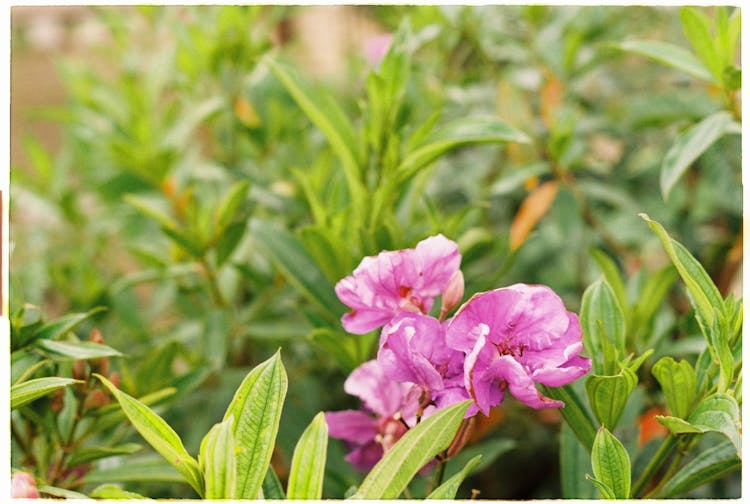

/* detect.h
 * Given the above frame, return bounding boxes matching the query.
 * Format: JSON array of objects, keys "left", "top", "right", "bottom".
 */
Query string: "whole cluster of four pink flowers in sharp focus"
[{"left": 326, "top": 235, "right": 591, "bottom": 470}]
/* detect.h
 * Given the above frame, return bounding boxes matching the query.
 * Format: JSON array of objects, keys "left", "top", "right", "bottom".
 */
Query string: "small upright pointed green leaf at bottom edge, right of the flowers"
[{"left": 591, "top": 427, "right": 630, "bottom": 499}]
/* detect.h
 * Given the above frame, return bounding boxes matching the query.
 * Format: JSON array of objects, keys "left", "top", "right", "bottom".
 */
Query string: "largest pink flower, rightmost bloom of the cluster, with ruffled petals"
[{"left": 446, "top": 284, "right": 591, "bottom": 415}]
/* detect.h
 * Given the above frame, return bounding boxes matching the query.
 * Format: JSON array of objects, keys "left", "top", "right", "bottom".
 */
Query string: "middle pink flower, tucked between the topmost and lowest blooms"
[{"left": 378, "top": 313, "right": 476, "bottom": 416}]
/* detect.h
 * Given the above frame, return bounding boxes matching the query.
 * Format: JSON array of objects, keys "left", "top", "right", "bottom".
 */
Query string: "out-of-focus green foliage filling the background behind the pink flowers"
[{"left": 10, "top": 6, "right": 742, "bottom": 499}]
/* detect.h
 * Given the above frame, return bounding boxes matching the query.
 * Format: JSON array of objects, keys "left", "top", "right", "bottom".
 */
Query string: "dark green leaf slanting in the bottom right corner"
[{"left": 658, "top": 441, "right": 742, "bottom": 498}]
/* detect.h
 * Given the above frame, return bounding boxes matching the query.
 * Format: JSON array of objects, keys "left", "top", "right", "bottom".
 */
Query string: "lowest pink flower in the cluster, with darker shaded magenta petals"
[{"left": 326, "top": 360, "right": 422, "bottom": 472}]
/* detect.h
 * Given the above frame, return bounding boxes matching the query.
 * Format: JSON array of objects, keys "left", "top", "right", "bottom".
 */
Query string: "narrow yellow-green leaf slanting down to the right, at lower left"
[{"left": 94, "top": 373, "right": 203, "bottom": 496}]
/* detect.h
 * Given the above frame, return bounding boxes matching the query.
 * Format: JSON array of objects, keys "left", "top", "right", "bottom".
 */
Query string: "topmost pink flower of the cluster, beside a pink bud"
[{"left": 336, "top": 234, "right": 461, "bottom": 334}]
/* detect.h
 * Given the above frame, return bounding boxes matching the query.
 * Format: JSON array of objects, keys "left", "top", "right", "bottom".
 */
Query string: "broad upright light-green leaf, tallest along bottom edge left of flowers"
[{"left": 224, "top": 352, "right": 287, "bottom": 499}]
